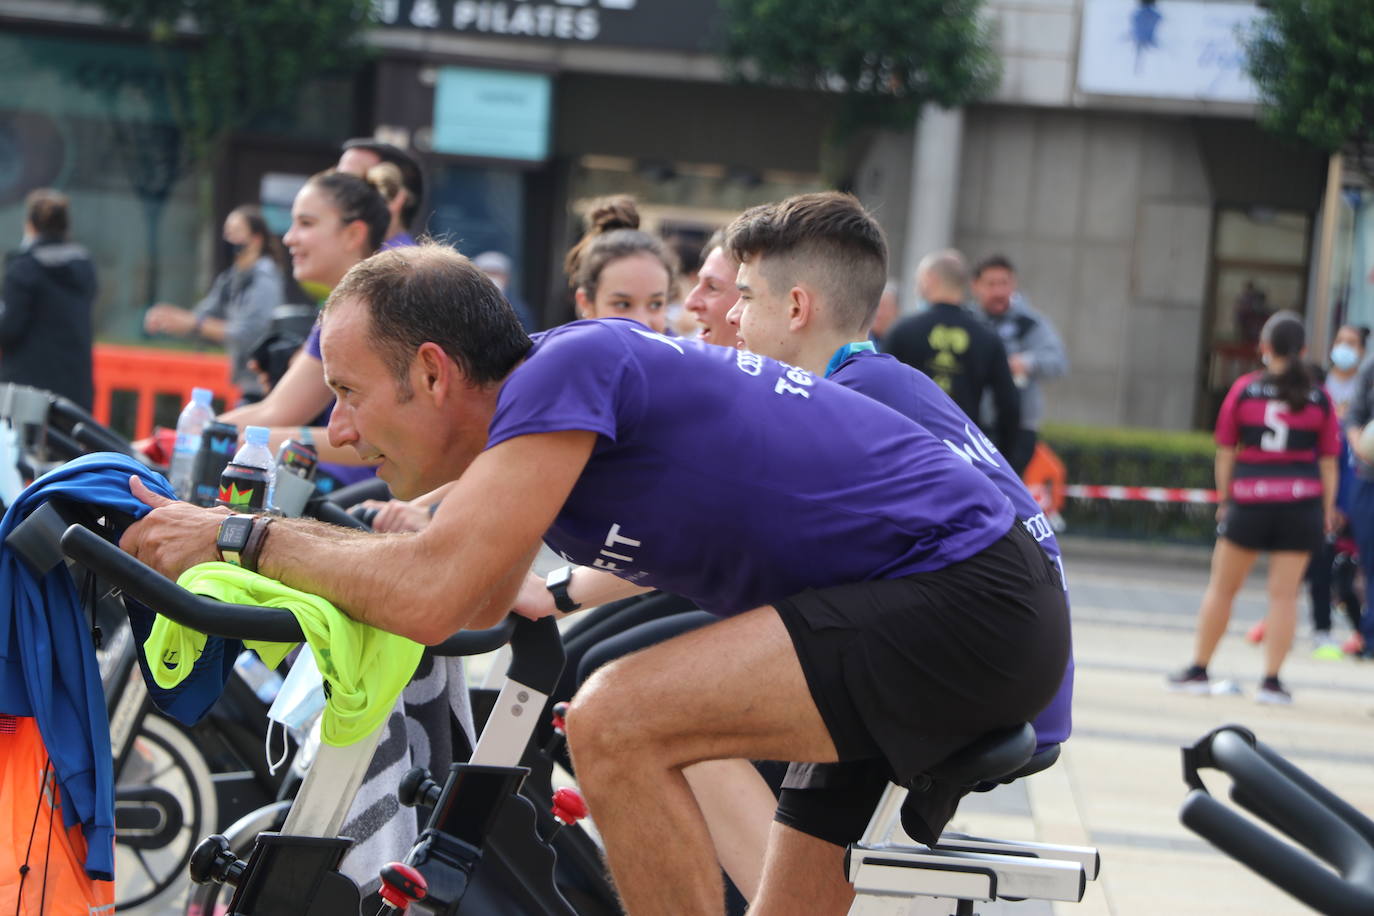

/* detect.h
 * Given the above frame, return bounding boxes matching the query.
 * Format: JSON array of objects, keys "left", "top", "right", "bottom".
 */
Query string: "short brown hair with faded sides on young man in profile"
[{"left": 725, "top": 191, "right": 888, "bottom": 334}]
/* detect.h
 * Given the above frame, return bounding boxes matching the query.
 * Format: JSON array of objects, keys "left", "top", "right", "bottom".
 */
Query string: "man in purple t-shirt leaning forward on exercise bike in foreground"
[{"left": 121, "top": 246, "right": 1069, "bottom": 913}]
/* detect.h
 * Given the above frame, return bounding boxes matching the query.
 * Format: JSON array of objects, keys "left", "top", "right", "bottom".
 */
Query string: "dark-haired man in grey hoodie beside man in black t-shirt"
[{"left": 973, "top": 254, "right": 1069, "bottom": 474}]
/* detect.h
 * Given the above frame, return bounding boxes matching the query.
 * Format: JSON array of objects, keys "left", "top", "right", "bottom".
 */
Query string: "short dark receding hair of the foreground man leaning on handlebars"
[{"left": 323, "top": 242, "right": 533, "bottom": 400}]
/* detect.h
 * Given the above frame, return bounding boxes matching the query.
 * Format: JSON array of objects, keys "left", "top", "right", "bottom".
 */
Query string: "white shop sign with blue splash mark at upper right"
[{"left": 1079, "top": 0, "right": 1261, "bottom": 103}]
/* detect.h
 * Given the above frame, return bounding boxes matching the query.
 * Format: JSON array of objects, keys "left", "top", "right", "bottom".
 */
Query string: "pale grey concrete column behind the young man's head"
[{"left": 899, "top": 104, "right": 963, "bottom": 313}]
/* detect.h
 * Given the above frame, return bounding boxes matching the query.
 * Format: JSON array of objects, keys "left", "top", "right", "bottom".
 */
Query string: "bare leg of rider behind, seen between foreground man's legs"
[{"left": 683, "top": 759, "right": 778, "bottom": 901}]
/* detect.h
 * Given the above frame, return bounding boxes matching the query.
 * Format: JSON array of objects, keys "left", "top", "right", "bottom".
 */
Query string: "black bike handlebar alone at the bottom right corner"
[{"left": 1179, "top": 725, "right": 1374, "bottom": 916}]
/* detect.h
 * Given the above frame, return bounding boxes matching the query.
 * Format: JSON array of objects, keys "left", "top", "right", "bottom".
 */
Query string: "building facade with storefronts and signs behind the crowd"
[{"left": 0, "top": 0, "right": 1330, "bottom": 428}]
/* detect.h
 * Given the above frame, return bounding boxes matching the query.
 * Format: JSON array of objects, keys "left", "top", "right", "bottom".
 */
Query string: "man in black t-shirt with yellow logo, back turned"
[{"left": 883, "top": 250, "right": 1021, "bottom": 455}]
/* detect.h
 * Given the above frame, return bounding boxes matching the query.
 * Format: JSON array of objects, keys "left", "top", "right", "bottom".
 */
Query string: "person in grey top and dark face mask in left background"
[{"left": 143, "top": 203, "right": 286, "bottom": 401}]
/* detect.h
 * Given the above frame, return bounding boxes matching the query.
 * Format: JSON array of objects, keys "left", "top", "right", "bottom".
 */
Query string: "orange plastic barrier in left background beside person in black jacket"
[{"left": 92, "top": 343, "right": 239, "bottom": 439}]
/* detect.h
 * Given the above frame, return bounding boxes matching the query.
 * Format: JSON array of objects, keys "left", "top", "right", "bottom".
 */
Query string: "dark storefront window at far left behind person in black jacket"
[{"left": 0, "top": 33, "right": 201, "bottom": 341}]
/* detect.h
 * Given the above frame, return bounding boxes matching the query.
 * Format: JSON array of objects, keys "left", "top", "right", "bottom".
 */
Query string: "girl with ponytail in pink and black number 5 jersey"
[{"left": 1168, "top": 312, "right": 1341, "bottom": 705}]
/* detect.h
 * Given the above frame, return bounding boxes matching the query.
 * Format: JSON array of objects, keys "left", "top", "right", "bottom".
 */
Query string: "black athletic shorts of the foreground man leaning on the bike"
[{"left": 775, "top": 525, "right": 1069, "bottom": 846}]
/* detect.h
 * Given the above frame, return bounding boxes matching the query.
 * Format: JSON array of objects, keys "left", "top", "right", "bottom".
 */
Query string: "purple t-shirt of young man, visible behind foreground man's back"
[{"left": 827, "top": 350, "right": 1073, "bottom": 748}]
